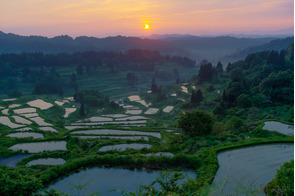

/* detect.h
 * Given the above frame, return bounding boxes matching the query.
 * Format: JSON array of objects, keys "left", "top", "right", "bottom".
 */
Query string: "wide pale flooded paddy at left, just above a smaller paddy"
[{"left": 9, "top": 141, "right": 67, "bottom": 153}]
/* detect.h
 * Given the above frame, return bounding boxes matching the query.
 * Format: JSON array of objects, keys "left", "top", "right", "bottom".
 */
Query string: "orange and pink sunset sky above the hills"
[{"left": 0, "top": 0, "right": 294, "bottom": 37}]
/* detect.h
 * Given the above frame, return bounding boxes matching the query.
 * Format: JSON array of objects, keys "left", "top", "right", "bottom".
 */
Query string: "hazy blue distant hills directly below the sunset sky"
[{"left": 0, "top": 31, "right": 284, "bottom": 62}]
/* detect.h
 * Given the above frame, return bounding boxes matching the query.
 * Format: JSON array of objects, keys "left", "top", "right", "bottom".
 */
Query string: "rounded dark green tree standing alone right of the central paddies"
[{"left": 178, "top": 110, "right": 213, "bottom": 137}]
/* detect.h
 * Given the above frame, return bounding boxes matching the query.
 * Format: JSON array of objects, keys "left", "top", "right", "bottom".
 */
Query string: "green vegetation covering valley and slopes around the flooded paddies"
[{"left": 0, "top": 43, "right": 294, "bottom": 195}]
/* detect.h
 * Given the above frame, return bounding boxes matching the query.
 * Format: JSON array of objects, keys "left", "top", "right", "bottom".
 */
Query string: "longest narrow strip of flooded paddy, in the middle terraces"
[{"left": 72, "top": 129, "right": 161, "bottom": 138}]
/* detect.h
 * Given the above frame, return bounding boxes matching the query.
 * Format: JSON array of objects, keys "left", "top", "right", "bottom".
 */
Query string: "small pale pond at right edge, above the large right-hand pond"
[{"left": 263, "top": 121, "right": 294, "bottom": 135}]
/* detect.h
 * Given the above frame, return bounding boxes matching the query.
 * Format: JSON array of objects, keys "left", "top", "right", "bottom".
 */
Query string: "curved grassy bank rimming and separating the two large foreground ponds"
[{"left": 33, "top": 137, "right": 294, "bottom": 195}]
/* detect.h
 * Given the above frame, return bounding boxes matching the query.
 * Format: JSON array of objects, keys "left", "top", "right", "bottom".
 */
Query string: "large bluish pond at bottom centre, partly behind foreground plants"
[{"left": 49, "top": 167, "right": 197, "bottom": 196}]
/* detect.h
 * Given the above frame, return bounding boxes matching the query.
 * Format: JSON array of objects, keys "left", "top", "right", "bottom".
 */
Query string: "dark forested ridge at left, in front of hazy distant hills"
[{"left": 0, "top": 49, "right": 195, "bottom": 71}]
